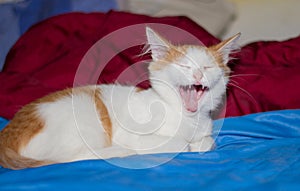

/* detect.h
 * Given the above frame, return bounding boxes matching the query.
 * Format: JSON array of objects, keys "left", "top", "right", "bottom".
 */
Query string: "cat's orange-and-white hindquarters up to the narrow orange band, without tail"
[{"left": 0, "top": 86, "right": 111, "bottom": 161}]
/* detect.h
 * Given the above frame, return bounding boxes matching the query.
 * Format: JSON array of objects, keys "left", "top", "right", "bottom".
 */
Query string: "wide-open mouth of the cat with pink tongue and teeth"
[{"left": 179, "top": 85, "right": 208, "bottom": 112}]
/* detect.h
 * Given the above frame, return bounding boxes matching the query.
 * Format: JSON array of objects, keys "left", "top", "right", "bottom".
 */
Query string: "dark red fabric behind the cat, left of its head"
[{"left": 0, "top": 11, "right": 219, "bottom": 119}]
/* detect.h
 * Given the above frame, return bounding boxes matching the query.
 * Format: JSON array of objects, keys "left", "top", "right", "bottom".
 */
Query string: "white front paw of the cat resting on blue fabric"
[{"left": 189, "top": 136, "right": 215, "bottom": 152}]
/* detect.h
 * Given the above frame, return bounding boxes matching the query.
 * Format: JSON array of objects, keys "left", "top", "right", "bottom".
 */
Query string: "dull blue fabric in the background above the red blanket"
[{"left": 0, "top": 0, "right": 117, "bottom": 71}]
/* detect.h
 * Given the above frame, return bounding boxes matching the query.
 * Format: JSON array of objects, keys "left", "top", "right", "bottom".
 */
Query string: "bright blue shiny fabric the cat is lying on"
[{"left": 0, "top": 110, "right": 300, "bottom": 191}]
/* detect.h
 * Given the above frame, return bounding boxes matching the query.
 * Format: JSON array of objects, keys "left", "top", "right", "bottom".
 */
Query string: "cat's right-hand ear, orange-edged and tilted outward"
[{"left": 211, "top": 33, "right": 241, "bottom": 64}]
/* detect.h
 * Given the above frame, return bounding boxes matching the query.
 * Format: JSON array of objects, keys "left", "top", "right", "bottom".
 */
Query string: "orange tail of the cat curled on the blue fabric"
[{"left": 0, "top": 143, "right": 52, "bottom": 170}]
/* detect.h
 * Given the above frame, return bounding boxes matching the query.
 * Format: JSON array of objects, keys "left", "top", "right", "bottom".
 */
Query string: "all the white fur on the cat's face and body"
[{"left": 21, "top": 28, "right": 239, "bottom": 162}]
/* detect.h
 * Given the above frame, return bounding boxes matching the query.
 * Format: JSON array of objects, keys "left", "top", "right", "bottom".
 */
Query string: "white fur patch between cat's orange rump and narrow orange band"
[{"left": 21, "top": 90, "right": 105, "bottom": 161}]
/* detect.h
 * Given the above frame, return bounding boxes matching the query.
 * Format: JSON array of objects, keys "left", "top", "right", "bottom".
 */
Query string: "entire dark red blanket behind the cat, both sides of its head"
[{"left": 0, "top": 11, "right": 300, "bottom": 119}]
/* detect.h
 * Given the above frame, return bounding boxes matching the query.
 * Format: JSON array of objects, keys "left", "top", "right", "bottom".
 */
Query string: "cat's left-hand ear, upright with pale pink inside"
[{"left": 146, "top": 27, "right": 171, "bottom": 61}]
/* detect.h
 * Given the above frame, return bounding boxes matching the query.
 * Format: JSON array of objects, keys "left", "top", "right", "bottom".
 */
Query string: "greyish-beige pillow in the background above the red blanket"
[{"left": 118, "top": 0, "right": 236, "bottom": 36}]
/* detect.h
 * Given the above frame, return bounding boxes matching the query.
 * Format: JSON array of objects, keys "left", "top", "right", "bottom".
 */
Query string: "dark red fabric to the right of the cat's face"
[{"left": 226, "top": 37, "right": 300, "bottom": 116}]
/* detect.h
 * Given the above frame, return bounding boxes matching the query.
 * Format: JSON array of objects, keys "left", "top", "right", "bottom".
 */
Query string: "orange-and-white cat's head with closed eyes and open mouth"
[{"left": 146, "top": 28, "right": 240, "bottom": 113}]
